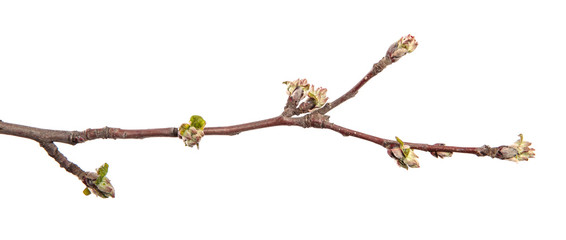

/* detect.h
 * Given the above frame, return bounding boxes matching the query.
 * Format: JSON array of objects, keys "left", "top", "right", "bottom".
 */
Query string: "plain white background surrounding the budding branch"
[{"left": 0, "top": 1, "right": 566, "bottom": 239}]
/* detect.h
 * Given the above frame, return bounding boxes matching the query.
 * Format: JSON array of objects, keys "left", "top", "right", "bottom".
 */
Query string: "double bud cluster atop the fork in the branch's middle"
[{"left": 283, "top": 79, "right": 328, "bottom": 112}]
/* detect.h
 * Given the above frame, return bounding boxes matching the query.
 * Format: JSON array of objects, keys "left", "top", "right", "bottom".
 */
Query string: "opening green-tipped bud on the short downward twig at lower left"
[{"left": 83, "top": 163, "right": 116, "bottom": 198}]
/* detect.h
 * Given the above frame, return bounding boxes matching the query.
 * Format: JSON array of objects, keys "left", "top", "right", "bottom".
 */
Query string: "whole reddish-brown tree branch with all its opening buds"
[{"left": 0, "top": 35, "right": 535, "bottom": 198}]
